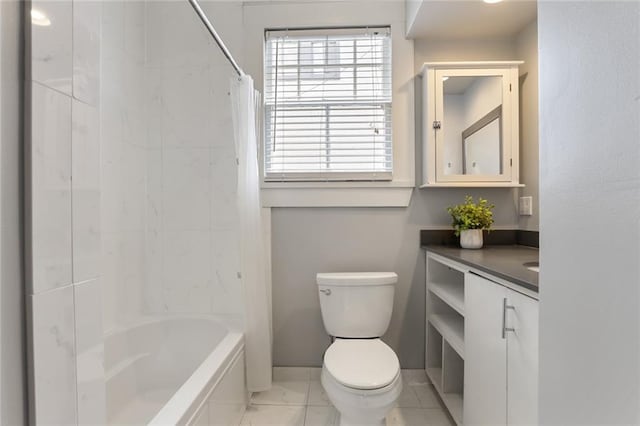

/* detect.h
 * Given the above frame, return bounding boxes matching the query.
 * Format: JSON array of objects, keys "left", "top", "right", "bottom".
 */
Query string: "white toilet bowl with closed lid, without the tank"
[{"left": 321, "top": 339, "right": 402, "bottom": 426}]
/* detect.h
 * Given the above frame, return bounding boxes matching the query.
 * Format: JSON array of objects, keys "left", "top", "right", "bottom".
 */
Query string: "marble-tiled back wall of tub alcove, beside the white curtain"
[{"left": 143, "top": 1, "right": 243, "bottom": 316}]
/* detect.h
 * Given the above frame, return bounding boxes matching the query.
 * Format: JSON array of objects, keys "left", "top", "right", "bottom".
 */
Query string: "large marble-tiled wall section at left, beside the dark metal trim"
[{"left": 25, "top": 1, "right": 105, "bottom": 424}]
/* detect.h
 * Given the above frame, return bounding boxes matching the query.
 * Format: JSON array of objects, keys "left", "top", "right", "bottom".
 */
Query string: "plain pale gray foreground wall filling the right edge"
[{"left": 538, "top": 1, "right": 640, "bottom": 425}]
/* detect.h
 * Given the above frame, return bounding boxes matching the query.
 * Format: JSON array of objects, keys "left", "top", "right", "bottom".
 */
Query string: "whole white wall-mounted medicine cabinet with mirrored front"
[{"left": 422, "top": 61, "right": 522, "bottom": 187}]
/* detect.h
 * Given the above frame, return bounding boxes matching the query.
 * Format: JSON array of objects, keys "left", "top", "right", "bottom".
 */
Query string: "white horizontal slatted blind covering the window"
[{"left": 264, "top": 27, "right": 393, "bottom": 181}]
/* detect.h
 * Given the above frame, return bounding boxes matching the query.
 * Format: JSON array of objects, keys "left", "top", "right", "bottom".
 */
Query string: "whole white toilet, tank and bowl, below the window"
[{"left": 317, "top": 272, "right": 402, "bottom": 426}]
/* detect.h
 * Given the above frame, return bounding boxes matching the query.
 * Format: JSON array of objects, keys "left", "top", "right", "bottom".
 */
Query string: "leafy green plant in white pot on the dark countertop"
[{"left": 447, "top": 195, "right": 495, "bottom": 249}]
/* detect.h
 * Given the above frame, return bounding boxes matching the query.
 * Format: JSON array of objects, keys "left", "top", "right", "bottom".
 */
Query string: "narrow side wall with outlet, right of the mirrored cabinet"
[{"left": 516, "top": 20, "right": 540, "bottom": 231}]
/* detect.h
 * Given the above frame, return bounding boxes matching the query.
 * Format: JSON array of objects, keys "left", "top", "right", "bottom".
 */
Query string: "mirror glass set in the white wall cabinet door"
[{"left": 441, "top": 75, "right": 503, "bottom": 175}]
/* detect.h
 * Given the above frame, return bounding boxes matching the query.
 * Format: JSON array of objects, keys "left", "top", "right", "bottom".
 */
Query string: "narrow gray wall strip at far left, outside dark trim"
[{"left": 0, "top": 0, "right": 26, "bottom": 425}]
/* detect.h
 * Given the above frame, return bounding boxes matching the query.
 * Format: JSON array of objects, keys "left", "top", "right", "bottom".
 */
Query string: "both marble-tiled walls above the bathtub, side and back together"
[{"left": 101, "top": 1, "right": 242, "bottom": 331}]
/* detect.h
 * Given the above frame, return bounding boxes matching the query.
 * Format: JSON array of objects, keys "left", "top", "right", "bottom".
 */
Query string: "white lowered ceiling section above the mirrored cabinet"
[{"left": 407, "top": 0, "right": 537, "bottom": 40}]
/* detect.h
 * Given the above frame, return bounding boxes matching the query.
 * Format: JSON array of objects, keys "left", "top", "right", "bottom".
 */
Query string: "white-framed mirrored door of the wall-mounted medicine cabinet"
[{"left": 432, "top": 67, "right": 518, "bottom": 182}]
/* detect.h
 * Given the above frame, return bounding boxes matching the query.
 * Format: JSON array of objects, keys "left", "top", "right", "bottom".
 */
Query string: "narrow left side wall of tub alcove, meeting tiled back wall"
[{"left": 100, "top": 1, "right": 147, "bottom": 331}]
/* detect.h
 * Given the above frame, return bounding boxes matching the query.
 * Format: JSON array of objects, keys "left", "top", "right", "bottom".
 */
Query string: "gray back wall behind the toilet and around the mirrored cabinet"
[{"left": 272, "top": 35, "right": 537, "bottom": 368}]
